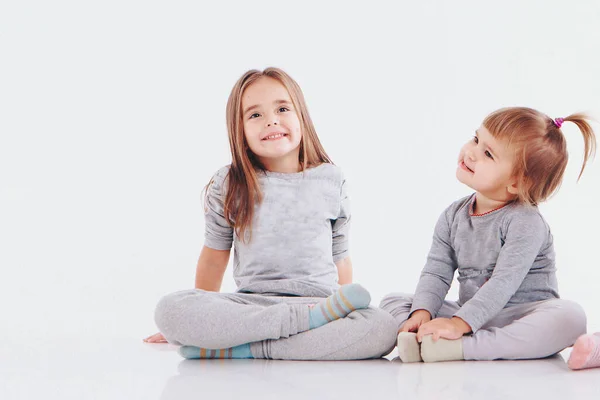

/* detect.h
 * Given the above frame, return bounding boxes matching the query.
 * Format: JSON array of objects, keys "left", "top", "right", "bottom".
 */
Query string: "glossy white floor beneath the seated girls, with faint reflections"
[{"left": 0, "top": 338, "right": 600, "bottom": 400}]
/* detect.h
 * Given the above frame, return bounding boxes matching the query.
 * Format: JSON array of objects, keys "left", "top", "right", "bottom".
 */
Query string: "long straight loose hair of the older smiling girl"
[{"left": 207, "top": 67, "right": 332, "bottom": 241}]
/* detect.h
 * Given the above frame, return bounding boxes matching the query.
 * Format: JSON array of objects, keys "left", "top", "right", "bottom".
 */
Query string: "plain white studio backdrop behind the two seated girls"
[{"left": 0, "top": 0, "right": 600, "bottom": 346}]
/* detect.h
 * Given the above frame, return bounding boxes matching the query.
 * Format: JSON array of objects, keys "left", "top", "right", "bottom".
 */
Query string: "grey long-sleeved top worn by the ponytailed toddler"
[{"left": 411, "top": 194, "right": 559, "bottom": 332}]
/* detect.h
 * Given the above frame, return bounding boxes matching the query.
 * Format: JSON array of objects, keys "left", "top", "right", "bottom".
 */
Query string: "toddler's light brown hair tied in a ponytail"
[{"left": 483, "top": 107, "right": 596, "bottom": 205}]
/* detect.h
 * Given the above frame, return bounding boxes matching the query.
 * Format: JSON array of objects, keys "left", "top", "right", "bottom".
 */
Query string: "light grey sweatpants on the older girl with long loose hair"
[{"left": 155, "top": 289, "right": 397, "bottom": 360}]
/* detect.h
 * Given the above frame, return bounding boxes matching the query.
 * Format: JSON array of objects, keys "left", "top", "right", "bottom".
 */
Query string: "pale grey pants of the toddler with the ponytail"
[{"left": 380, "top": 293, "right": 586, "bottom": 360}]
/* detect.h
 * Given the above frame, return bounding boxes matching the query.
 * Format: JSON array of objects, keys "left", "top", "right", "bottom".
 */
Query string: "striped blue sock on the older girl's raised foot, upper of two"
[{"left": 308, "top": 283, "right": 371, "bottom": 329}]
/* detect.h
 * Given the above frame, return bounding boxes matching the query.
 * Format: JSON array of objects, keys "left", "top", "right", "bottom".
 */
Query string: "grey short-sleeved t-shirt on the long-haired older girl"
[{"left": 204, "top": 163, "right": 350, "bottom": 297}]
